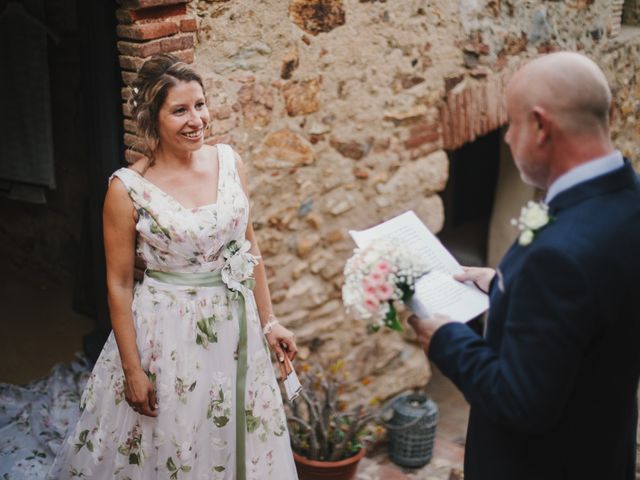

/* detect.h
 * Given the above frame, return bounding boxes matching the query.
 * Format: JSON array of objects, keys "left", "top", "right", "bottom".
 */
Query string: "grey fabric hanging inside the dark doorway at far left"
[{"left": 0, "top": 0, "right": 59, "bottom": 199}]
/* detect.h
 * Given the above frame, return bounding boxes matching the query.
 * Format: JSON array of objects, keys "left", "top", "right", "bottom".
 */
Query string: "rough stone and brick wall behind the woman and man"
[{"left": 119, "top": 0, "right": 640, "bottom": 398}]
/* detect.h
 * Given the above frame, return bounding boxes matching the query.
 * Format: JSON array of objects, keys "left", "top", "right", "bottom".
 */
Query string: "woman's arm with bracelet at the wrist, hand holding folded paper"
[{"left": 234, "top": 152, "right": 298, "bottom": 378}]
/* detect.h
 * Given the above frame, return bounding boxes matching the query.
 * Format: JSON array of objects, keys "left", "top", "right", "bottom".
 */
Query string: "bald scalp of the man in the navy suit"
[{"left": 508, "top": 52, "right": 611, "bottom": 134}]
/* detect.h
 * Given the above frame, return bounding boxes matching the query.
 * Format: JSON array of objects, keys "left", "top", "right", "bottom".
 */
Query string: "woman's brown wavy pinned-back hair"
[{"left": 130, "top": 53, "right": 205, "bottom": 168}]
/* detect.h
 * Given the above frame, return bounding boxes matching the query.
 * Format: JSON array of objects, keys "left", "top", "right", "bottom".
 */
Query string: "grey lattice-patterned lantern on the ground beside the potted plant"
[{"left": 386, "top": 393, "right": 438, "bottom": 468}]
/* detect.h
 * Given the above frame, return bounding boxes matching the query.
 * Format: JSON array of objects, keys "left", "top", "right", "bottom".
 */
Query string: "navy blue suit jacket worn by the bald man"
[{"left": 429, "top": 162, "right": 640, "bottom": 480}]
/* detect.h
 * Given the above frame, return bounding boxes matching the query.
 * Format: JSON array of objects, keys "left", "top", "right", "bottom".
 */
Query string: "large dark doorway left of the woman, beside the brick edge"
[{"left": 0, "top": 0, "right": 123, "bottom": 383}]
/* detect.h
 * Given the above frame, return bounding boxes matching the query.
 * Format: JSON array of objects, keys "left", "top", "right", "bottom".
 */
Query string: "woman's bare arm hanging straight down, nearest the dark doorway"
[{"left": 102, "top": 178, "right": 155, "bottom": 416}]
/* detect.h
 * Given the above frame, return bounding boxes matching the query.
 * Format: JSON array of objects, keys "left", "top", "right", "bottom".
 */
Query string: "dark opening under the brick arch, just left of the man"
[{"left": 438, "top": 130, "right": 501, "bottom": 266}]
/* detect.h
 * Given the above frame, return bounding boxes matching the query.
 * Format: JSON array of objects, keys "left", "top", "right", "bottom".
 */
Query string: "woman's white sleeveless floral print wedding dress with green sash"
[{"left": 49, "top": 145, "right": 297, "bottom": 480}]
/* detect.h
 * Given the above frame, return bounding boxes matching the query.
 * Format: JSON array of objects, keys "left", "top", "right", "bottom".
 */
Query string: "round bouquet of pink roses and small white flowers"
[{"left": 342, "top": 241, "right": 429, "bottom": 331}]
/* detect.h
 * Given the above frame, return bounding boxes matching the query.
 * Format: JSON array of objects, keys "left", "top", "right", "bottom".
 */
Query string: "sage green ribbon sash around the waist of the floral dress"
[{"left": 146, "top": 270, "right": 253, "bottom": 480}]
